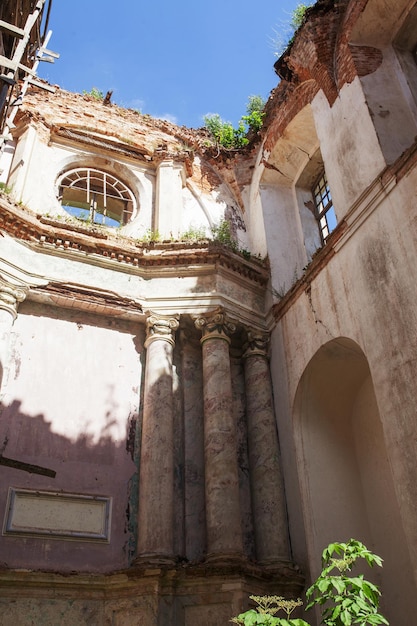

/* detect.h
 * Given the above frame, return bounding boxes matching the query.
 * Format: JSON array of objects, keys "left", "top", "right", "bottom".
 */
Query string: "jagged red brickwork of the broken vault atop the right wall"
[{"left": 263, "top": 0, "right": 382, "bottom": 150}]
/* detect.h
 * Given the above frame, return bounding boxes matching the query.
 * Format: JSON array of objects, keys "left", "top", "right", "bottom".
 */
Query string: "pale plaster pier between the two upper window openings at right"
[{"left": 312, "top": 78, "right": 385, "bottom": 214}]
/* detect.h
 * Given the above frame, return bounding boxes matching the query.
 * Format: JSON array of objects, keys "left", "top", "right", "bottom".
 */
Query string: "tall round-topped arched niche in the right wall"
[{"left": 294, "top": 337, "right": 417, "bottom": 626}]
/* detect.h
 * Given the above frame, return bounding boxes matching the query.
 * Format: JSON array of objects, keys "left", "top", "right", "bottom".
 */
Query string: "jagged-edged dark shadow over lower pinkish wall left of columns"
[{"left": 0, "top": 400, "right": 138, "bottom": 572}]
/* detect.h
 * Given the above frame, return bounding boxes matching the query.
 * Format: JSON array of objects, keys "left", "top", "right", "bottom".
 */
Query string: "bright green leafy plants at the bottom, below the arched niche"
[{"left": 231, "top": 539, "right": 388, "bottom": 626}]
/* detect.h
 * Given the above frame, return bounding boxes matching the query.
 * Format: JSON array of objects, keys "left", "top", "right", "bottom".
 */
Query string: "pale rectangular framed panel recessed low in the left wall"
[{"left": 3, "top": 488, "right": 111, "bottom": 541}]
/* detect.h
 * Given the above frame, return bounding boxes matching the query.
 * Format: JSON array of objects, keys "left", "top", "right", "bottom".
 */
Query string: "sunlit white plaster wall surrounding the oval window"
[{"left": 3, "top": 116, "right": 236, "bottom": 248}]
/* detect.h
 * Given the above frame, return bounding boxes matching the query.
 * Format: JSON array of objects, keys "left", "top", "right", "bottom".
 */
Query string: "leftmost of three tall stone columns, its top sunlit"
[{"left": 137, "top": 313, "right": 178, "bottom": 565}]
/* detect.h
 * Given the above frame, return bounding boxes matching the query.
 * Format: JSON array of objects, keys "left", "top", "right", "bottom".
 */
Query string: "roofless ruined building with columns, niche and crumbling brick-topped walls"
[{"left": 0, "top": 0, "right": 417, "bottom": 626}]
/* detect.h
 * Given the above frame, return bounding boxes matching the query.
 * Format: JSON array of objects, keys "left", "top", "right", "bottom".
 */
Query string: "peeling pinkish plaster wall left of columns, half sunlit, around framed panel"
[{"left": 0, "top": 303, "right": 144, "bottom": 571}]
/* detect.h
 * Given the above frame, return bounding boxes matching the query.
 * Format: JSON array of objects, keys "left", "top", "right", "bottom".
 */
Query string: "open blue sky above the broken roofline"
[{"left": 39, "top": 0, "right": 299, "bottom": 128}]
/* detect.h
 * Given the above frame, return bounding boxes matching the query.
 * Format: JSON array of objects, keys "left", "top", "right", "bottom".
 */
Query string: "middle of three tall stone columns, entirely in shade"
[{"left": 195, "top": 311, "right": 243, "bottom": 563}]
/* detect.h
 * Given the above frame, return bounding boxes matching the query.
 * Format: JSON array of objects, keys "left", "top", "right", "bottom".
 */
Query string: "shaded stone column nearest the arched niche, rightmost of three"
[{"left": 243, "top": 332, "right": 290, "bottom": 565}]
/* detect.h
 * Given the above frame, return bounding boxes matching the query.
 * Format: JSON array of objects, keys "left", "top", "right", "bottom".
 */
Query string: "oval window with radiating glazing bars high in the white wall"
[{"left": 58, "top": 167, "right": 136, "bottom": 227}]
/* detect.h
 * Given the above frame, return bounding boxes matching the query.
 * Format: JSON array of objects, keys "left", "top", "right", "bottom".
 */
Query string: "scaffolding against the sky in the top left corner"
[{"left": 0, "top": 0, "right": 59, "bottom": 153}]
